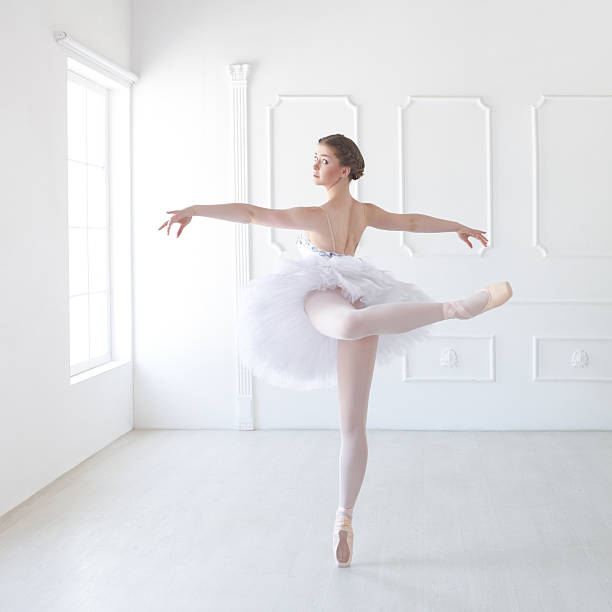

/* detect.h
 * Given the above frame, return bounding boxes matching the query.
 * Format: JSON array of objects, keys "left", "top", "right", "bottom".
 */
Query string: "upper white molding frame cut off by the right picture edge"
[{"left": 531, "top": 94, "right": 612, "bottom": 259}]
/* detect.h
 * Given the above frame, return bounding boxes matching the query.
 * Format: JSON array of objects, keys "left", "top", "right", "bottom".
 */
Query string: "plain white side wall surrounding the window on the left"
[{"left": 0, "top": 0, "right": 133, "bottom": 515}]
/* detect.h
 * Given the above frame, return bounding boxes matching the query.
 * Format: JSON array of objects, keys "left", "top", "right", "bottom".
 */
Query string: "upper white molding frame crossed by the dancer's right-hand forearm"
[{"left": 398, "top": 96, "right": 494, "bottom": 259}]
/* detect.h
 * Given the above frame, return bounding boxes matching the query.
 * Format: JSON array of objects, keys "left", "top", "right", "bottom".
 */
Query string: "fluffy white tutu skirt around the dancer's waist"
[{"left": 236, "top": 233, "right": 435, "bottom": 390}]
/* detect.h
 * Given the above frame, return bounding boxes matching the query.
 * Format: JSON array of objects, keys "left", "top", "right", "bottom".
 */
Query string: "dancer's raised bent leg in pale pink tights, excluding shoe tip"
[{"left": 304, "top": 289, "right": 488, "bottom": 340}]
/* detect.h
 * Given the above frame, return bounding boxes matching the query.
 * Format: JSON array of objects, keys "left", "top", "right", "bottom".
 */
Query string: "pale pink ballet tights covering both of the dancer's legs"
[{"left": 304, "top": 290, "right": 488, "bottom": 518}]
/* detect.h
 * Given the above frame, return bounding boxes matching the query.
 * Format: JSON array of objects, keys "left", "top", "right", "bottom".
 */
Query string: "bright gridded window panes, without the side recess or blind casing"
[{"left": 67, "top": 70, "right": 111, "bottom": 375}]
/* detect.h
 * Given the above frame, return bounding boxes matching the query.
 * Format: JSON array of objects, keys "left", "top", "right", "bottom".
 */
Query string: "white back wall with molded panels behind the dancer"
[{"left": 132, "top": 0, "right": 612, "bottom": 429}]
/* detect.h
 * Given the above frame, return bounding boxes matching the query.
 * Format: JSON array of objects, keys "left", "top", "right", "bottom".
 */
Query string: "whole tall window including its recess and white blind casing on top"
[{"left": 55, "top": 43, "right": 138, "bottom": 385}]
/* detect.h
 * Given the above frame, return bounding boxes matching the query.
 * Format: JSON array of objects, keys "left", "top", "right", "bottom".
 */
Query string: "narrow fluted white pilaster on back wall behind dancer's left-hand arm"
[{"left": 228, "top": 64, "right": 255, "bottom": 431}]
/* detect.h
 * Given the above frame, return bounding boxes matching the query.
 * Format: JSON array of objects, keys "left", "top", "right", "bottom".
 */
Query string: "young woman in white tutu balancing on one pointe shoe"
[{"left": 159, "top": 134, "right": 512, "bottom": 567}]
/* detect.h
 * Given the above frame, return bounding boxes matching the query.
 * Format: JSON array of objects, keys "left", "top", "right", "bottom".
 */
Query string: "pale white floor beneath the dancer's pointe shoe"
[{"left": 0, "top": 430, "right": 612, "bottom": 612}]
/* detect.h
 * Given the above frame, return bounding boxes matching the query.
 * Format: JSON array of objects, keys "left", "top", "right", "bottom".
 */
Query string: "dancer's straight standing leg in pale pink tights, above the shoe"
[{"left": 338, "top": 336, "right": 378, "bottom": 517}]
